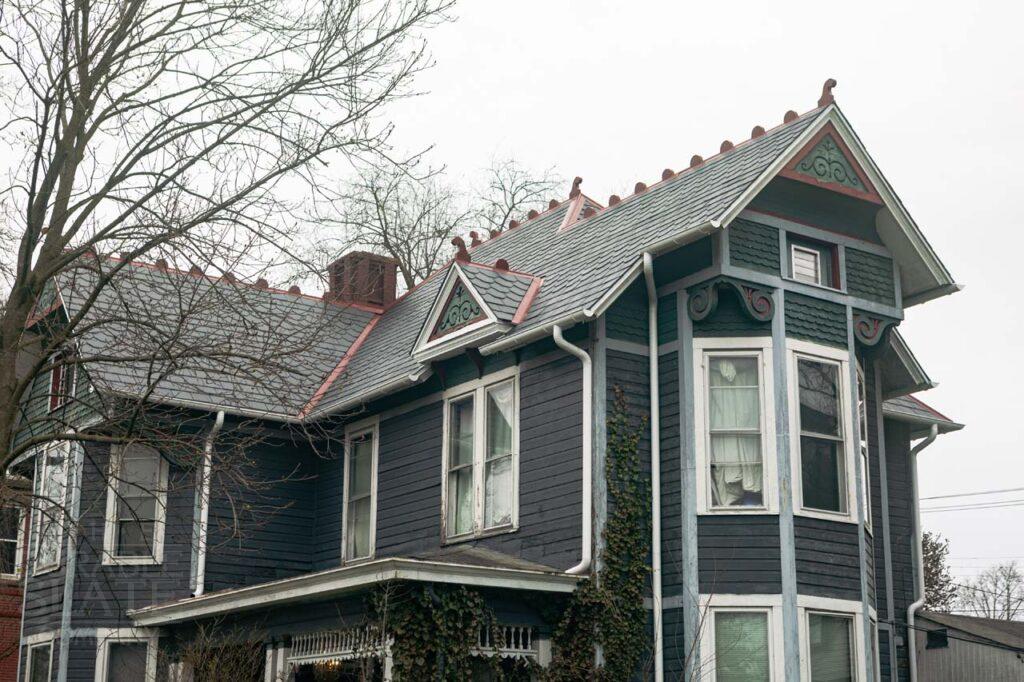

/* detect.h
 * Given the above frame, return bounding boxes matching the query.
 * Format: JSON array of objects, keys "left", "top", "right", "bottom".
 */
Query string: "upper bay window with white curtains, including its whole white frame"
[{"left": 694, "top": 339, "right": 775, "bottom": 512}]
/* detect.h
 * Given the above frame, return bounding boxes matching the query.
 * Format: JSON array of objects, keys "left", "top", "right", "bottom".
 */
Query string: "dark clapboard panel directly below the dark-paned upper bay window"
[{"left": 793, "top": 516, "right": 860, "bottom": 599}]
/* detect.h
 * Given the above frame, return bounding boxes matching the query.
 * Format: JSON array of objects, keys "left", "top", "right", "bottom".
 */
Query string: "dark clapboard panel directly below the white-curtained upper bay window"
[{"left": 697, "top": 514, "right": 782, "bottom": 594}]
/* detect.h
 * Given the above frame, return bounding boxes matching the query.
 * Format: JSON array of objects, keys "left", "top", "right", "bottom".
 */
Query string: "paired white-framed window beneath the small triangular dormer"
[{"left": 444, "top": 378, "right": 519, "bottom": 538}]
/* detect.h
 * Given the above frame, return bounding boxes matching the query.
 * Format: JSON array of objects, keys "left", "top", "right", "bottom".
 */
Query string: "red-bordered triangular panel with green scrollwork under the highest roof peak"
[{"left": 780, "top": 123, "right": 883, "bottom": 204}]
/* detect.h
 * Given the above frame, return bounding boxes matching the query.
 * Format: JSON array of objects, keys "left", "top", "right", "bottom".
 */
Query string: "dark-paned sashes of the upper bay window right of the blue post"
[{"left": 797, "top": 355, "right": 848, "bottom": 514}]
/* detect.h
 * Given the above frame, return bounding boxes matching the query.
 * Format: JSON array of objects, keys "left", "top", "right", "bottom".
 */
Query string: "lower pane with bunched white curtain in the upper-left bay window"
[{"left": 711, "top": 434, "right": 764, "bottom": 506}]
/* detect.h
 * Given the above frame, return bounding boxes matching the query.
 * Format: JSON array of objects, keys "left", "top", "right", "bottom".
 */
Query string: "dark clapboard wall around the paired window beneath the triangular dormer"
[{"left": 377, "top": 353, "right": 583, "bottom": 568}]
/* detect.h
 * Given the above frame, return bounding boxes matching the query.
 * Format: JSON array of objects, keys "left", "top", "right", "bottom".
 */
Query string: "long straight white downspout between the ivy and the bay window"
[{"left": 643, "top": 253, "right": 665, "bottom": 682}]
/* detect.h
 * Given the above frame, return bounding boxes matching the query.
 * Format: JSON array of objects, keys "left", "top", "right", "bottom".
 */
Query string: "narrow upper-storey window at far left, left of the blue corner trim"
[{"left": 33, "top": 442, "right": 70, "bottom": 574}]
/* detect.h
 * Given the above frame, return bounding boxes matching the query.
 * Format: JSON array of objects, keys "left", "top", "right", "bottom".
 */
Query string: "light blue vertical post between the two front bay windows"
[{"left": 771, "top": 289, "right": 800, "bottom": 680}]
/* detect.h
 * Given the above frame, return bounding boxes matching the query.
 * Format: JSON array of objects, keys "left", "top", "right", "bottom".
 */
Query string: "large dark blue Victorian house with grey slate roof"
[{"left": 9, "top": 81, "right": 959, "bottom": 681}]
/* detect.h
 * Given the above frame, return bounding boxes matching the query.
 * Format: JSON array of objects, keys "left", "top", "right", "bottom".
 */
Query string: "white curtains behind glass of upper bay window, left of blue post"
[{"left": 708, "top": 357, "right": 764, "bottom": 506}]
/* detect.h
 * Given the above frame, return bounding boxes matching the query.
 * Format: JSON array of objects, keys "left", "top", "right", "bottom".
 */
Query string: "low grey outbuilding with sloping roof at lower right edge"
[{"left": 916, "top": 611, "right": 1024, "bottom": 682}]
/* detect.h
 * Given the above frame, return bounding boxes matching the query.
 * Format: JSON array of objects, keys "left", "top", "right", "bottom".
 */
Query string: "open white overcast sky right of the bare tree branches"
[{"left": 382, "top": 0, "right": 1024, "bottom": 576}]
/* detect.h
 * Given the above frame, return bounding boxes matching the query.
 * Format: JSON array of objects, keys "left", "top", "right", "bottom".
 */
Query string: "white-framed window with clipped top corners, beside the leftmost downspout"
[{"left": 103, "top": 444, "right": 167, "bottom": 564}]
